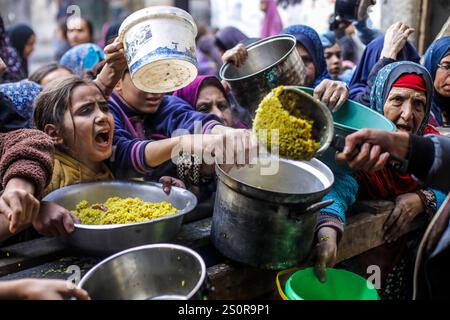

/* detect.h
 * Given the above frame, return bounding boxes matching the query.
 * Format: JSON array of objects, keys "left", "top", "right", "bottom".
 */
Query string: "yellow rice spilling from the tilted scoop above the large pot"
[{"left": 254, "top": 86, "right": 320, "bottom": 160}]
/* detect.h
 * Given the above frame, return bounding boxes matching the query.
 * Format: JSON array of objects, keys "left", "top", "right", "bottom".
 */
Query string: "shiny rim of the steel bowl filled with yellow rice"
[{"left": 43, "top": 180, "right": 198, "bottom": 231}]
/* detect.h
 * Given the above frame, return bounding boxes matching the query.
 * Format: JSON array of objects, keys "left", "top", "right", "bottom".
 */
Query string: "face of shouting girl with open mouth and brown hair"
[{"left": 63, "top": 85, "right": 114, "bottom": 168}]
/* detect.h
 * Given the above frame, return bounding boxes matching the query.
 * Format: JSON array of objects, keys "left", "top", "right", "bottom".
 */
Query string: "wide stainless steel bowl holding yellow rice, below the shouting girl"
[{"left": 43, "top": 181, "right": 197, "bottom": 256}]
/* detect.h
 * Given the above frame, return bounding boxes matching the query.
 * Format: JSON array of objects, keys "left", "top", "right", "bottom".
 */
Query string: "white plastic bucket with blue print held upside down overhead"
[{"left": 119, "top": 6, "right": 198, "bottom": 93}]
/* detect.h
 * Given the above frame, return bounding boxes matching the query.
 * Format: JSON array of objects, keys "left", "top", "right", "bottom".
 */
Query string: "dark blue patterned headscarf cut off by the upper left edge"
[{"left": 0, "top": 17, "right": 26, "bottom": 83}]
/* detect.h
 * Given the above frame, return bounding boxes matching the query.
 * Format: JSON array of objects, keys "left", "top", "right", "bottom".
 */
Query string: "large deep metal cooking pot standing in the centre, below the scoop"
[{"left": 211, "top": 159, "right": 334, "bottom": 270}]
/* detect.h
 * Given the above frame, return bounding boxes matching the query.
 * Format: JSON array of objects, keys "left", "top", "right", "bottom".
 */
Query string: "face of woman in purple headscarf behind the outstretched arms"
[{"left": 195, "top": 86, "right": 233, "bottom": 127}]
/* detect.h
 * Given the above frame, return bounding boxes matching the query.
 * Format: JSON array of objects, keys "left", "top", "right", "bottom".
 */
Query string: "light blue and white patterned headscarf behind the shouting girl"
[{"left": 59, "top": 43, "right": 105, "bottom": 77}]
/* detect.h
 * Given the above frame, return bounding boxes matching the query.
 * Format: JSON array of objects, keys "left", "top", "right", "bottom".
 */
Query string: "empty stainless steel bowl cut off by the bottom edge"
[{"left": 78, "top": 244, "right": 206, "bottom": 300}]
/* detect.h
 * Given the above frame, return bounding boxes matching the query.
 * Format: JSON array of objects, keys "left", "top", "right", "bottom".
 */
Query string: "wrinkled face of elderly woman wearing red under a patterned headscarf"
[{"left": 383, "top": 88, "right": 427, "bottom": 134}]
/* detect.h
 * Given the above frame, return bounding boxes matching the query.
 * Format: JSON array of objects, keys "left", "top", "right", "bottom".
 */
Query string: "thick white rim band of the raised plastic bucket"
[{"left": 118, "top": 6, "right": 198, "bottom": 40}]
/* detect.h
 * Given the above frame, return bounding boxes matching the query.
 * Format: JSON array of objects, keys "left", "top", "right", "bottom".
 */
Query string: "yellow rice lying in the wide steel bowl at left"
[{"left": 72, "top": 197, "right": 178, "bottom": 225}]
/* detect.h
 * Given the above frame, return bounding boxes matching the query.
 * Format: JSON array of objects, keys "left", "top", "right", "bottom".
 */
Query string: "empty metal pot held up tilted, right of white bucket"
[{"left": 220, "top": 35, "right": 306, "bottom": 116}]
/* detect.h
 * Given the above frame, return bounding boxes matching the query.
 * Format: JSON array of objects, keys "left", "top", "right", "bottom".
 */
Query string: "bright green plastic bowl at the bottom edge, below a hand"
[{"left": 285, "top": 268, "right": 380, "bottom": 300}]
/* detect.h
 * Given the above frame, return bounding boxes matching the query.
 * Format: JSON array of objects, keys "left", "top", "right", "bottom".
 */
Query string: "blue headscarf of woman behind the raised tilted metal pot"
[{"left": 283, "top": 25, "right": 331, "bottom": 88}]
